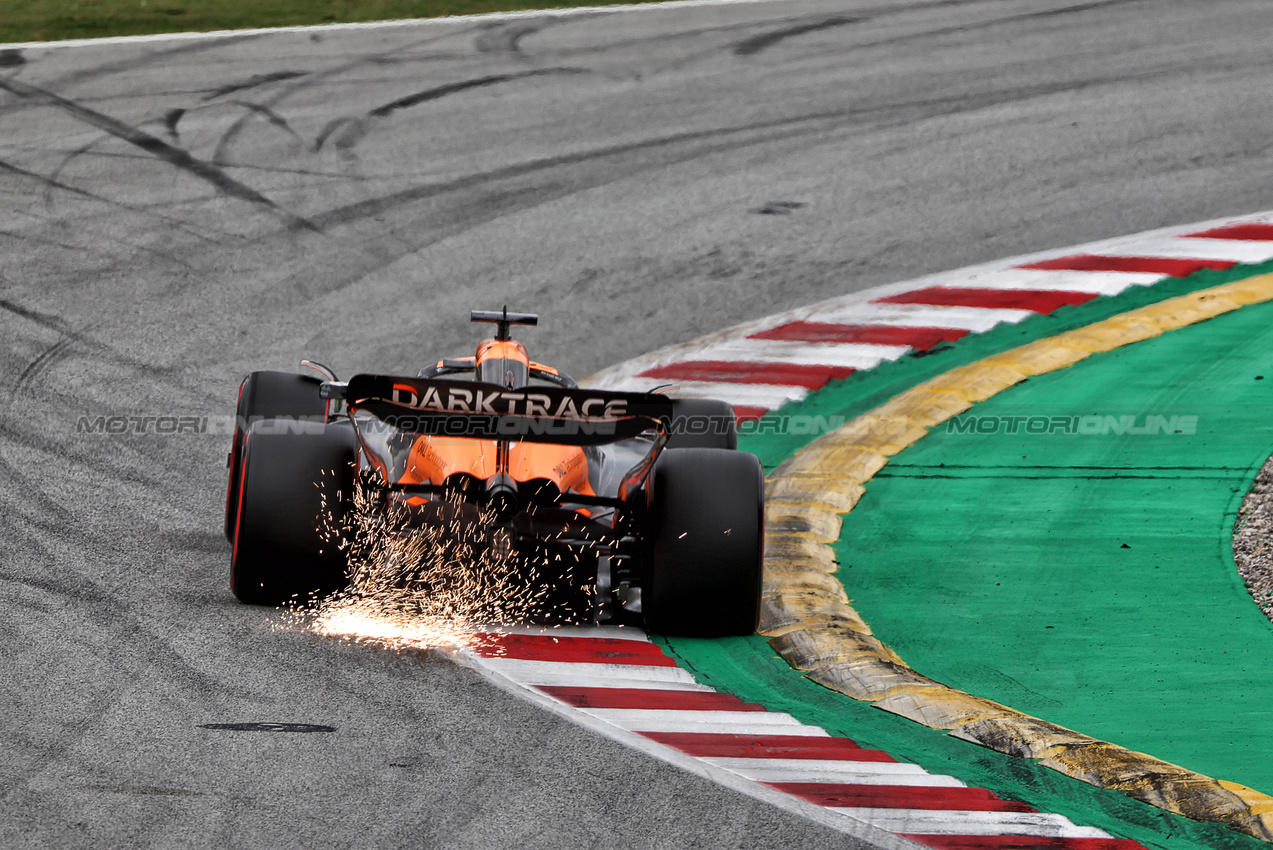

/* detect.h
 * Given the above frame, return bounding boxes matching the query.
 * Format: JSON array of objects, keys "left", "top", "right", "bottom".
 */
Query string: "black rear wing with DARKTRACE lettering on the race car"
[{"left": 322, "top": 374, "right": 672, "bottom": 445}]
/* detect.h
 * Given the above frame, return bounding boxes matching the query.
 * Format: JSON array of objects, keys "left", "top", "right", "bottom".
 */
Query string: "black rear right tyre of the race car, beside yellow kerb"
[{"left": 642, "top": 449, "right": 764, "bottom": 638}]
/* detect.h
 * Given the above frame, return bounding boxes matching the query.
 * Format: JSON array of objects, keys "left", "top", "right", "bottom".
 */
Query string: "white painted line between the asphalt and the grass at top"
[{"left": 0, "top": 0, "right": 782, "bottom": 50}]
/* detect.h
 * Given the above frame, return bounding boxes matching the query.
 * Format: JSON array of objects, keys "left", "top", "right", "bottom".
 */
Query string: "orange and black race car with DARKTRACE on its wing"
[{"left": 225, "top": 308, "right": 764, "bottom": 636}]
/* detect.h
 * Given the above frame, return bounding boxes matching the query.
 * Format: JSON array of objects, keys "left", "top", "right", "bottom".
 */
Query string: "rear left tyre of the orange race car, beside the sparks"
[{"left": 230, "top": 420, "right": 355, "bottom": 606}]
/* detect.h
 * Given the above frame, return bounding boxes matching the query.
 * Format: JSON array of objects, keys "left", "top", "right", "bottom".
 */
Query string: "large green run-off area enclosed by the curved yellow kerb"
[{"left": 836, "top": 297, "right": 1273, "bottom": 790}]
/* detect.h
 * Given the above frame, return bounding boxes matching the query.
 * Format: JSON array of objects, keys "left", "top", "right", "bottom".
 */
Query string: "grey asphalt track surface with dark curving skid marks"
[{"left": 7, "top": 0, "right": 1273, "bottom": 847}]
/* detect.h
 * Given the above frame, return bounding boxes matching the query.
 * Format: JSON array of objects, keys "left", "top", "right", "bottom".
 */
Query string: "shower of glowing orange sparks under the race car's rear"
[{"left": 294, "top": 470, "right": 596, "bottom": 648}]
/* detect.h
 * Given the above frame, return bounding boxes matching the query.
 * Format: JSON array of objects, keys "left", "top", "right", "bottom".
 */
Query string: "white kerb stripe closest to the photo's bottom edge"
[{"left": 830, "top": 807, "right": 1110, "bottom": 839}]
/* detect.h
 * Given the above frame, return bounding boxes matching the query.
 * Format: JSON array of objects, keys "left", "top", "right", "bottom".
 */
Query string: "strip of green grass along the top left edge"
[{"left": 0, "top": 0, "right": 672, "bottom": 43}]
